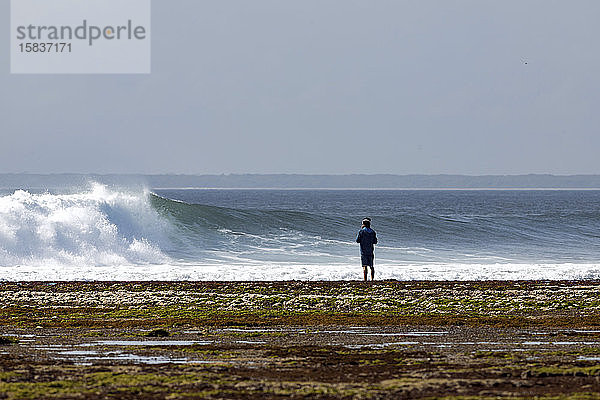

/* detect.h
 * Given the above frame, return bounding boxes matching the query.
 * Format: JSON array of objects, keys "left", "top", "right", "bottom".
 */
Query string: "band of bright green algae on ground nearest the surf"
[{"left": 0, "top": 281, "right": 600, "bottom": 328}]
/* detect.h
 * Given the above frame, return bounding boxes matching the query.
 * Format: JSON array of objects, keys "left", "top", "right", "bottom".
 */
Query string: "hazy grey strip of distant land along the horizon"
[{"left": 0, "top": 173, "right": 600, "bottom": 189}]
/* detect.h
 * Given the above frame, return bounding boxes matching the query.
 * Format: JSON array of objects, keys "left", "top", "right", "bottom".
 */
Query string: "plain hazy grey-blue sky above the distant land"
[{"left": 0, "top": 0, "right": 600, "bottom": 175}]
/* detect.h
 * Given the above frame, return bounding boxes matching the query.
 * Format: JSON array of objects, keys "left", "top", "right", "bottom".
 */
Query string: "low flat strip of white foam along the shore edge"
[{"left": 0, "top": 259, "right": 600, "bottom": 281}]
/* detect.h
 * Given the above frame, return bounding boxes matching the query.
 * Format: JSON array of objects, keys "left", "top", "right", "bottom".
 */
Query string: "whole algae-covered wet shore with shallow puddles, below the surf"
[{"left": 0, "top": 281, "right": 600, "bottom": 399}]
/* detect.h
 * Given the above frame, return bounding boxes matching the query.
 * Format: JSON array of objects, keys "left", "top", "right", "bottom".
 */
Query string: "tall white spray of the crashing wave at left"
[{"left": 0, "top": 184, "right": 169, "bottom": 272}]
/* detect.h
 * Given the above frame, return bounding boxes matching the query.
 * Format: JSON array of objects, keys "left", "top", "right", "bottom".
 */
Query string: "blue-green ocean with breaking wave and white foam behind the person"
[{"left": 0, "top": 183, "right": 600, "bottom": 281}]
